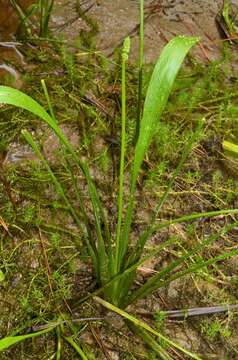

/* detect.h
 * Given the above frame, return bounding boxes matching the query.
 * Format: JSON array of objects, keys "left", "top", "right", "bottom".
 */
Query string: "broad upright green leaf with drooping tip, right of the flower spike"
[{"left": 119, "top": 36, "right": 199, "bottom": 270}]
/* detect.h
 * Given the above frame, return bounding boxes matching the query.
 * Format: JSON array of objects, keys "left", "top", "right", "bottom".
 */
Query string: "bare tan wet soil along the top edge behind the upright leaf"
[{"left": 51, "top": 0, "right": 223, "bottom": 63}]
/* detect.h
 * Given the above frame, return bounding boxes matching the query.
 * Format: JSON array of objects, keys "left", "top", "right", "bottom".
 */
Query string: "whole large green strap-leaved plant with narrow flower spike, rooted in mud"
[{"left": 0, "top": 11, "right": 238, "bottom": 359}]
